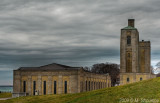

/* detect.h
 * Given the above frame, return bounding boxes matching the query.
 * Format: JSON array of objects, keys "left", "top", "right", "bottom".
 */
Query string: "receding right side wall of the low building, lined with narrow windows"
[{"left": 80, "top": 71, "right": 111, "bottom": 92}]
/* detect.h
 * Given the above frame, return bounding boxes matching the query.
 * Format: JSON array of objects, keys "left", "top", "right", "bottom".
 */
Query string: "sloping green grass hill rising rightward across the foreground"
[{"left": 0, "top": 78, "right": 160, "bottom": 103}]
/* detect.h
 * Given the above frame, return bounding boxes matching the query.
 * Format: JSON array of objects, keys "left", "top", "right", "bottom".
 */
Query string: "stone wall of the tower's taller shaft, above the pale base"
[{"left": 120, "top": 29, "right": 139, "bottom": 73}]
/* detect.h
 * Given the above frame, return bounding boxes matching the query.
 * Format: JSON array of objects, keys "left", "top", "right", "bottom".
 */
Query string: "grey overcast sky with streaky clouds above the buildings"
[{"left": 0, "top": 0, "right": 160, "bottom": 85}]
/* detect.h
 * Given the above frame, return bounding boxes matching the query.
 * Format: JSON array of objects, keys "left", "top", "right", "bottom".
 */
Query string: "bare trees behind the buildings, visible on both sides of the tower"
[{"left": 84, "top": 62, "right": 160, "bottom": 86}]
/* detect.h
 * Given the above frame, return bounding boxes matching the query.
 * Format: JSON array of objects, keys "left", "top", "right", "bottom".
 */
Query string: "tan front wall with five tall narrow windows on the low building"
[{"left": 13, "top": 70, "right": 78, "bottom": 95}]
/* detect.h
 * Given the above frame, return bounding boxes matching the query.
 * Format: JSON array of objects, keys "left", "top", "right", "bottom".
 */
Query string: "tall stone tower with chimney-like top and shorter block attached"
[{"left": 120, "top": 19, "right": 155, "bottom": 85}]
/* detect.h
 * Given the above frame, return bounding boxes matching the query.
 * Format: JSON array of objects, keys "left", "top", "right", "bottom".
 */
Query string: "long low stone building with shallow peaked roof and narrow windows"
[{"left": 13, "top": 63, "right": 111, "bottom": 97}]
